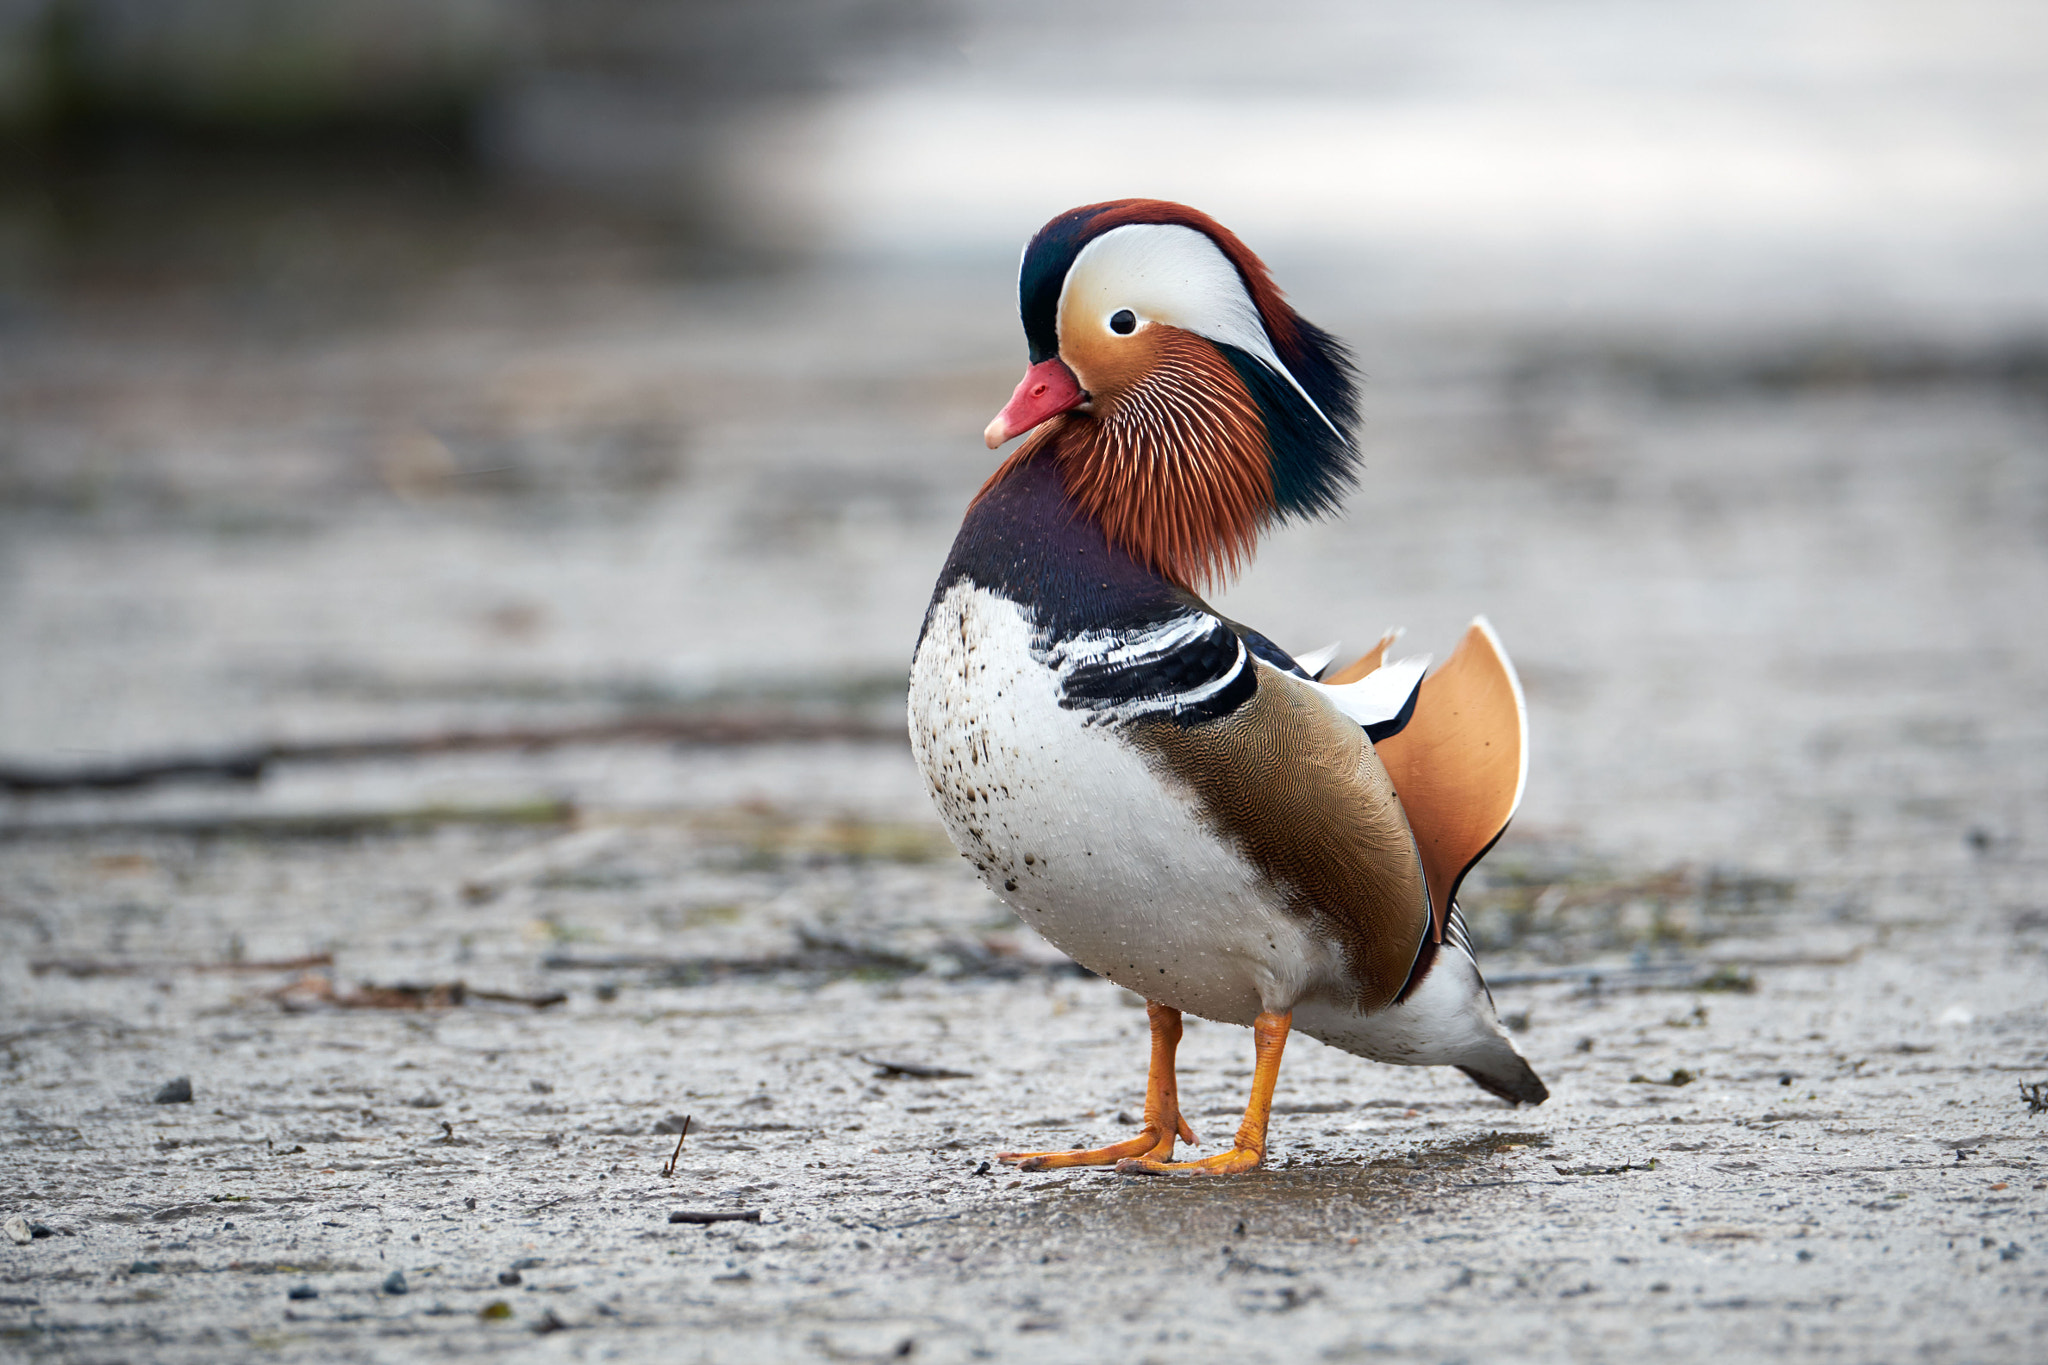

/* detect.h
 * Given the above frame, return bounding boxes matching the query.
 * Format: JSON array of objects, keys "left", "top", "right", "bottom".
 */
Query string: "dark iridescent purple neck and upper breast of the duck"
[{"left": 934, "top": 446, "right": 1198, "bottom": 636}]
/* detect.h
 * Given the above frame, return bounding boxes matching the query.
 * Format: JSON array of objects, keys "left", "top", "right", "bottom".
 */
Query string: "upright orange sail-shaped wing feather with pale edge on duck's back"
[{"left": 1346, "top": 616, "right": 1530, "bottom": 941}]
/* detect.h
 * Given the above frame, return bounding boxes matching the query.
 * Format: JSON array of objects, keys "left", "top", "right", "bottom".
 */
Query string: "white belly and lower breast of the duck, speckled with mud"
[{"left": 909, "top": 583, "right": 1343, "bottom": 1023}]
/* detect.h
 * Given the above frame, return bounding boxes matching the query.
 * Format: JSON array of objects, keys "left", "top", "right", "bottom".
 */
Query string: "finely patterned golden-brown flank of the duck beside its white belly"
[{"left": 1126, "top": 659, "right": 1432, "bottom": 1011}]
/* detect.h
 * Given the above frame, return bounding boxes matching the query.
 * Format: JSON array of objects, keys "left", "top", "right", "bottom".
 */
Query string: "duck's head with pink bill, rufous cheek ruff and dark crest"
[{"left": 985, "top": 199, "right": 1358, "bottom": 589}]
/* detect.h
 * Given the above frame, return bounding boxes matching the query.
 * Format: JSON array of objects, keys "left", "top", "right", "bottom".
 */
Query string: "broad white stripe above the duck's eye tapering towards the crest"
[{"left": 1059, "top": 223, "right": 1343, "bottom": 440}]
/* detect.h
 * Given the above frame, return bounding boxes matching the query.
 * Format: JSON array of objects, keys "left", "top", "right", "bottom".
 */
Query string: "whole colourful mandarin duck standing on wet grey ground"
[{"left": 909, "top": 199, "right": 1548, "bottom": 1173}]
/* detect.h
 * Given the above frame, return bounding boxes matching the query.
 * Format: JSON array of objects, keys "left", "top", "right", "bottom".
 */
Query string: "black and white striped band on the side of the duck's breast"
[{"left": 1040, "top": 610, "right": 1260, "bottom": 724}]
